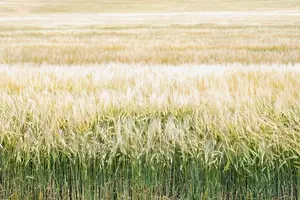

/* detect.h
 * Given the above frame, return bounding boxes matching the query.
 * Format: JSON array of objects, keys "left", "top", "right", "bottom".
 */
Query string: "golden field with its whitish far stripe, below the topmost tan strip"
[{"left": 0, "top": 12, "right": 300, "bottom": 65}]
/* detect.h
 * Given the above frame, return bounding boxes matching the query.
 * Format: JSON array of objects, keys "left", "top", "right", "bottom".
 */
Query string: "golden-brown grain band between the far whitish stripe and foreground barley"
[{"left": 0, "top": 25, "right": 300, "bottom": 64}]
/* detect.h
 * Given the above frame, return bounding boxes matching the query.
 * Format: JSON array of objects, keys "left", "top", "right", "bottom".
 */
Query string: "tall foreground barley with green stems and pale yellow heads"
[{"left": 0, "top": 65, "right": 300, "bottom": 199}]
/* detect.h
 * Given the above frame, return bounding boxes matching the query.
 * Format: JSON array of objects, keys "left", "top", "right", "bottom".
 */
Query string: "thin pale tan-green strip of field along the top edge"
[{"left": 0, "top": 0, "right": 300, "bottom": 14}]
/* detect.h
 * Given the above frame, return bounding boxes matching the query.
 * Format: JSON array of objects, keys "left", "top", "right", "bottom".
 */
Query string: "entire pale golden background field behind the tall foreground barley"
[{"left": 0, "top": 0, "right": 300, "bottom": 65}]
